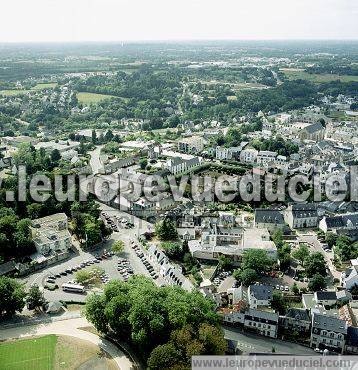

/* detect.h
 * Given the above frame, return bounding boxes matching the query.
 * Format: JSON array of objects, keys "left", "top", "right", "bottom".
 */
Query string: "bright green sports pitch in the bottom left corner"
[{"left": 0, "top": 335, "right": 57, "bottom": 370}]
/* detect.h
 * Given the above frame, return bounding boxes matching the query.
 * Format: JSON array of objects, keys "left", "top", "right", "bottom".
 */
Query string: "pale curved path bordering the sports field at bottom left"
[{"left": 0, "top": 318, "right": 133, "bottom": 370}]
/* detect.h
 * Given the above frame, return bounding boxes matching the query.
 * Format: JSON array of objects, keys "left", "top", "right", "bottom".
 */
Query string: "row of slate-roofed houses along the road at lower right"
[{"left": 219, "top": 284, "right": 358, "bottom": 354}]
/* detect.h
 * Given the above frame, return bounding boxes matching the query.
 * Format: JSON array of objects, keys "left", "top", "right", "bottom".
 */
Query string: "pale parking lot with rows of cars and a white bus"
[{"left": 22, "top": 204, "right": 164, "bottom": 302}]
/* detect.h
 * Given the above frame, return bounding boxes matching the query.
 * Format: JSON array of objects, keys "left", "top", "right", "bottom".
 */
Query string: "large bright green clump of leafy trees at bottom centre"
[{"left": 85, "top": 276, "right": 222, "bottom": 358}]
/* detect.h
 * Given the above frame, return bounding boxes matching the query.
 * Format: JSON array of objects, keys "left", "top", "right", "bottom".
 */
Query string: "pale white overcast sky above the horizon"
[{"left": 0, "top": 0, "right": 358, "bottom": 42}]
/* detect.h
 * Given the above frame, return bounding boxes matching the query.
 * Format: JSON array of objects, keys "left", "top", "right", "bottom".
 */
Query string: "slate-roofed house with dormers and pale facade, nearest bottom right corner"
[{"left": 310, "top": 312, "right": 348, "bottom": 353}]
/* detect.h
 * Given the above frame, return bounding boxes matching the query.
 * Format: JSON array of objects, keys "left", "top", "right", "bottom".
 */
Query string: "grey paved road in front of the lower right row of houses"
[{"left": 224, "top": 327, "right": 315, "bottom": 355}]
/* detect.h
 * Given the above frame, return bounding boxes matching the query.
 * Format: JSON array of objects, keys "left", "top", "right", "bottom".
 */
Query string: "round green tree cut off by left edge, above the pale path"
[{"left": 0, "top": 277, "right": 26, "bottom": 317}]
